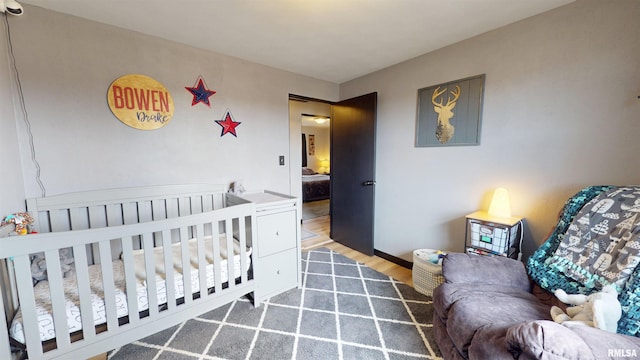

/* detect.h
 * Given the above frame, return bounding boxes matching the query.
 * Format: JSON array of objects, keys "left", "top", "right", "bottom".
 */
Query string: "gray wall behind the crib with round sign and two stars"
[{"left": 0, "top": 6, "right": 338, "bottom": 202}]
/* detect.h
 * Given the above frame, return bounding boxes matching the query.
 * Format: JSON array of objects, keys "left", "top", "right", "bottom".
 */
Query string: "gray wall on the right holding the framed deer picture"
[{"left": 340, "top": 0, "right": 640, "bottom": 260}]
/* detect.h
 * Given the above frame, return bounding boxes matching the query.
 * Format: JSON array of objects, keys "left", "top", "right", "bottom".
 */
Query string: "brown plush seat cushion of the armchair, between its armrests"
[{"left": 433, "top": 283, "right": 551, "bottom": 357}]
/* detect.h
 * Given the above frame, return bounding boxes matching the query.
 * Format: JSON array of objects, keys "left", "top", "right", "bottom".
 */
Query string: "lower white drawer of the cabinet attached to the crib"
[{"left": 256, "top": 249, "right": 299, "bottom": 301}]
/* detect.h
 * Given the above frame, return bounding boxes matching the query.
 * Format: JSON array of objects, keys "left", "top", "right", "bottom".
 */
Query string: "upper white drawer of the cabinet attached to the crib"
[{"left": 257, "top": 210, "right": 298, "bottom": 257}]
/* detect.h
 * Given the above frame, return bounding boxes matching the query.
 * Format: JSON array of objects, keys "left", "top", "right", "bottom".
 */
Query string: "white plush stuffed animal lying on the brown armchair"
[{"left": 551, "top": 285, "right": 622, "bottom": 333}]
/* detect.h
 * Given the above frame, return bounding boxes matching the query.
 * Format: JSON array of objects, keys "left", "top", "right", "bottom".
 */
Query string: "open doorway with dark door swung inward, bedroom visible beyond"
[{"left": 289, "top": 93, "right": 377, "bottom": 255}]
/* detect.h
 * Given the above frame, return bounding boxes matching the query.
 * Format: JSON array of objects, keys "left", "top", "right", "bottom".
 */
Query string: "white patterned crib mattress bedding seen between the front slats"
[{"left": 9, "top": 234, "right": 252, "bottom": 343}]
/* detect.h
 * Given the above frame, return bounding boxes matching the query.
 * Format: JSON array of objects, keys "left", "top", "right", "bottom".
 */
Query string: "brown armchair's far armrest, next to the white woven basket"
[{"left": 442, "top": 253, "right": 531, "bottom": 292}]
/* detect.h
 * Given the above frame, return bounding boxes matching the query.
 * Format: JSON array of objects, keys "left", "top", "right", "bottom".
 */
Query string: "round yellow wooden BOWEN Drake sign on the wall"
[{"left": 107, "top": 74, "right": 174, "bottom": 130}]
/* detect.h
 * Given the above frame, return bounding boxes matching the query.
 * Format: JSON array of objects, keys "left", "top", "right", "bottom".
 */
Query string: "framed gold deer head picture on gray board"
[{"left": 416, "top": 74, "right": 484, "bottom": 147}]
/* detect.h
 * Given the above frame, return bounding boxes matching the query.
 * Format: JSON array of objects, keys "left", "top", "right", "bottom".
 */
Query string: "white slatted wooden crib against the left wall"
[{"left": 0, "top": 184, "right": 258, "bottom": 359}]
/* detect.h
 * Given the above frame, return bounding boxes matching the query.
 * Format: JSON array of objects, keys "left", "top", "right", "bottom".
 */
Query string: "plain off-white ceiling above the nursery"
[{"left": 19, "top": 0, "right": 574, "bottom": 83}]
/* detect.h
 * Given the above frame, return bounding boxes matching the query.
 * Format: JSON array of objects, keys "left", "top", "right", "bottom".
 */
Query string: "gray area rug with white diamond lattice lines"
[{"left": 109, "top": 248, "right": 441, "bottom": 360}]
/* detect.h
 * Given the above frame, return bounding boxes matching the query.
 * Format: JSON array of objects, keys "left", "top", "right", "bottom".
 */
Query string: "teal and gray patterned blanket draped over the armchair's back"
[{"left": 527, "top": 186, "right": 640, "bottom": 337}]
